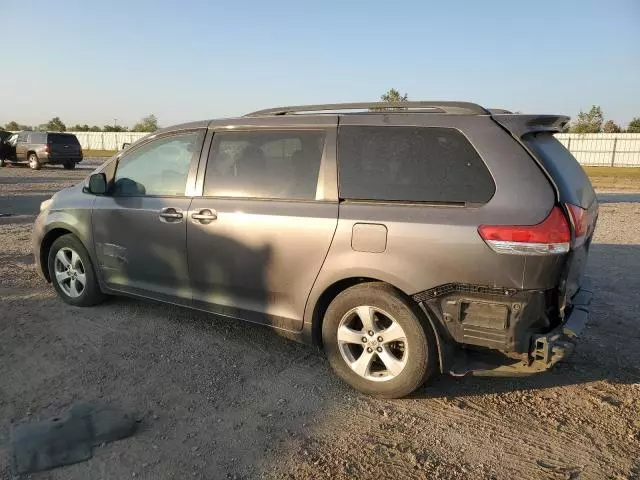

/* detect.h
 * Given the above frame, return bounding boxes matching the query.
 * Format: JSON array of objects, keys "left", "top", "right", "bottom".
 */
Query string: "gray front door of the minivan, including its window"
[{"left": 92, "top": 131, "right": 204, "bottom": 304}]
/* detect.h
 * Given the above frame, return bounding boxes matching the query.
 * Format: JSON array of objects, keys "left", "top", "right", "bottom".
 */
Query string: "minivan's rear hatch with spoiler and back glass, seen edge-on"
[{"left": 493, "top": 115, "right": 598, "bottom": 309}]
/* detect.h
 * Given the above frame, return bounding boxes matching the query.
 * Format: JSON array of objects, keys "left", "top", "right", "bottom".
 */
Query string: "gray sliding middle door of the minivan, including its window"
[{"left": 187, "top": 127, "right": 338, "bottom": 330}]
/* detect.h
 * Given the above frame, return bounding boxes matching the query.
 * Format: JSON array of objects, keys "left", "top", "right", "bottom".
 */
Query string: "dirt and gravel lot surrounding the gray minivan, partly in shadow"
[{"left": 0, "top": 162, "right": 640, "bottom": 480}]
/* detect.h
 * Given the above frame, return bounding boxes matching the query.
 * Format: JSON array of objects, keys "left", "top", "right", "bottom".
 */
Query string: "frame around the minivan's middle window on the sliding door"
[{"left": 194, "top": 124, "right": 338, "bottom": 203}]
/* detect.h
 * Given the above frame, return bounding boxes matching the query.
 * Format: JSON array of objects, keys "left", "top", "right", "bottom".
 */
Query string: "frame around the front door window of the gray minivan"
[{"left": 109, "top": 127, "right": 206, "bottom": 198}]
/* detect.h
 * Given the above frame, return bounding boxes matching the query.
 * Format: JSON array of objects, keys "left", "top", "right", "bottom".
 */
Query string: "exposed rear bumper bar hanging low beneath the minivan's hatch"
[{"left": 449, "top": 287, "right": 593, "bottom": 376}]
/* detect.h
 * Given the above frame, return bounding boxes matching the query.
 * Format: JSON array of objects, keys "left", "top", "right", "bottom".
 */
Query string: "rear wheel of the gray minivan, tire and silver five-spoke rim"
[{"left": 322, "top": 283, "right": 436, "bottom": 398}]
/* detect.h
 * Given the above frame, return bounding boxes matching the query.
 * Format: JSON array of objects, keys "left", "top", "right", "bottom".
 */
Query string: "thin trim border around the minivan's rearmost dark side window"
[{"left": 336, "top": 123, "right": 498, "bottom": 208}]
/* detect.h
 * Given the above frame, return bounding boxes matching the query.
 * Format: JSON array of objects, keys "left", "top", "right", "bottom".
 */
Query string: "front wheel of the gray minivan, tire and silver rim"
[{"left": 47, "top": 234, "right": 106, "bottom": 307}]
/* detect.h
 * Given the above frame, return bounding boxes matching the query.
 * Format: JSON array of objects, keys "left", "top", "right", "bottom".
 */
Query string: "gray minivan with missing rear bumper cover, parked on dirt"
[{"left": 33, "top": 102, "right": 598, "bottom": 397}]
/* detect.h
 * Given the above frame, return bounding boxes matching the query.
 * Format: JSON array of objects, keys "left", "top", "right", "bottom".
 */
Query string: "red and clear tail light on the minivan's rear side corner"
[{"left": 478, "top": 206, "right": 571, "bottom": 255}]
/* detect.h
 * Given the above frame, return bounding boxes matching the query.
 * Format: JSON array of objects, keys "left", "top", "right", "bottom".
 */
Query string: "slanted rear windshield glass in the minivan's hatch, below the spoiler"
[{"left": 523, "top": 133, "right": 596, "bottom": 208}]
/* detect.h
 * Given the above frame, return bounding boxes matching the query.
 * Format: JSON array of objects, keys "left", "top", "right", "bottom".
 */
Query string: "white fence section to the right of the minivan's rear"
[{"left": 556, "top": 133, "right": 640, "bottom": 167}]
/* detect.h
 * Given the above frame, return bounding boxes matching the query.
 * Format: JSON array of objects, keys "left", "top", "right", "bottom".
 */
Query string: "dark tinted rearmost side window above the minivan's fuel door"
[{"left": 338, "top": 126, "right": 496, "bottom": 203}]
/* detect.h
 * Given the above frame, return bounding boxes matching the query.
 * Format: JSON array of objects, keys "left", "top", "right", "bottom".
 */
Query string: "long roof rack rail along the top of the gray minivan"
[{"left": 245, "top": 101, "right": 490, "bottom": 117}]
